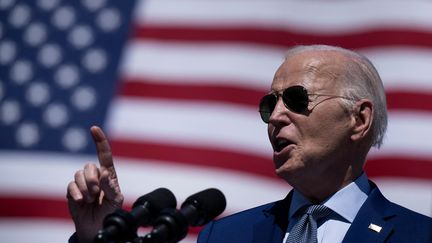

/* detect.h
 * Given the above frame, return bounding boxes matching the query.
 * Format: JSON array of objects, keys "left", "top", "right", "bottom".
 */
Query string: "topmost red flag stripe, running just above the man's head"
[{"left": 134, "top": 25, "right": 432, "bottom": 49}]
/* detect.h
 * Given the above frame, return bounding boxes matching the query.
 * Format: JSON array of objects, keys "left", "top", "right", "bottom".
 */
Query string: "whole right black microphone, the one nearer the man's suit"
[{"left": 141, "top": 188, "right": 226, "bottom": 243}]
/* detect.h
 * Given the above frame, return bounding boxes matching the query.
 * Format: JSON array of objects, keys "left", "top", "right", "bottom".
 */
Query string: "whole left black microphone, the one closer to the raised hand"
[{"left": 95, "top": 188, "right": 177, "bottom": 243}]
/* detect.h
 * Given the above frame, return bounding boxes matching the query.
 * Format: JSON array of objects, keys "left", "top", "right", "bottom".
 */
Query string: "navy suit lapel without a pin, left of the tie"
[{"left": 253, "top": 191, "right": 292, "bottom": 243}]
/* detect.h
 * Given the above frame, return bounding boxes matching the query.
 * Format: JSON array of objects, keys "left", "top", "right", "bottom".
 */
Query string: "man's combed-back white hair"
[{"left": 285, "top": 45, "right": 387, "bottom": 148}]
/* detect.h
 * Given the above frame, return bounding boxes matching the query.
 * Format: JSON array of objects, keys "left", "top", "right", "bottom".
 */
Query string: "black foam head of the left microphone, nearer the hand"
[{"left": 132, "top": 187, "right": 177, "bottom": 213}]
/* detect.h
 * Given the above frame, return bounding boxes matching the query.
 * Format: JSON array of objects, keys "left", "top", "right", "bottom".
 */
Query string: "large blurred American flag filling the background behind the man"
[{"left": 0, "top": 0, "right": 432, "bottom": 242}]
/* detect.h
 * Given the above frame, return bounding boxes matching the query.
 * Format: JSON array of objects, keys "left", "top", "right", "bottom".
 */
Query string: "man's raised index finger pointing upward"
[{"left": 90, "top": 126, "right": 114, "bottom": 170}]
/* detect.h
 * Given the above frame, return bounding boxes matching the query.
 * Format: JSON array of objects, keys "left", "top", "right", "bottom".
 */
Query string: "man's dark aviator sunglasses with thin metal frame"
[{"left": 259, "top": 85, "right": 351, "bottom": 123}]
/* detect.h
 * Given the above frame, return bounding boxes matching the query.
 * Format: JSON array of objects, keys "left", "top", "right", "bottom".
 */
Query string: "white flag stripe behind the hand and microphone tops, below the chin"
[{"left": 0, "top": 152, "right": 290, "bottom": 213}]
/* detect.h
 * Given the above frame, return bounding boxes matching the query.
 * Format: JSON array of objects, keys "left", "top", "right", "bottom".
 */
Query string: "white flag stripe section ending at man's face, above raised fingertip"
[{"left": 107, "top": 98, "right": 272, "bottom": 156}]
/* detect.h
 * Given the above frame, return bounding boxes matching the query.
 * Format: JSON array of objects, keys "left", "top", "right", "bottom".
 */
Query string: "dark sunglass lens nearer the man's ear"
[{"left": 282, "top": 86, "right": 309, "bottom": 113}]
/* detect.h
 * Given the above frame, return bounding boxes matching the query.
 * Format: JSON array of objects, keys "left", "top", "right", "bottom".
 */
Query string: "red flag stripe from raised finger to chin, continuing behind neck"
[{"left": 112, "top": 139, "right": 432, "bottom": 180}]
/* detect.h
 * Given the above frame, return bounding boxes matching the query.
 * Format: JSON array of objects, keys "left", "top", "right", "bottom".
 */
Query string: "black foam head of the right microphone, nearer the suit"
[{"left": 181, "top": 188, "right": 226, "bottom": 226}]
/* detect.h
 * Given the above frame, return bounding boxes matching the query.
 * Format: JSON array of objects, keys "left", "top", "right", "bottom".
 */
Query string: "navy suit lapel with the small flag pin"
[{"left": 343, "top": 182, "right": 396, "bottom": 243}]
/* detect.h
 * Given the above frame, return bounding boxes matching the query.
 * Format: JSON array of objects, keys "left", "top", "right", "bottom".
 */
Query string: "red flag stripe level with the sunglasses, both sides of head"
[{"left": 121, "top": 80, "right": 432, "bottom": 111}]
